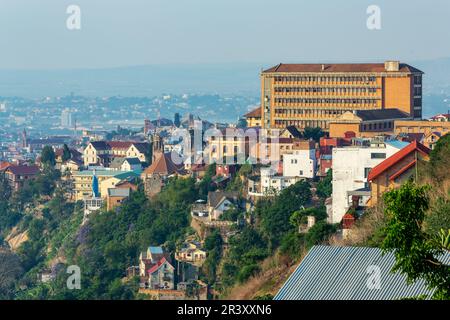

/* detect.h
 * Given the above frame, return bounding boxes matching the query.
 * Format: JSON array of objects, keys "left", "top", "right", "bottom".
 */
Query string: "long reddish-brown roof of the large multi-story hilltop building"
[{"left": 263, "top": 63, "right": 423, "bottom": 73}]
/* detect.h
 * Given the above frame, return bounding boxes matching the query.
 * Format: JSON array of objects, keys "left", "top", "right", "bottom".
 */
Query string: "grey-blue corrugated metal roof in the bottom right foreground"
[{"left": 274, "top": 246, "right": 450, "bottom": 300}]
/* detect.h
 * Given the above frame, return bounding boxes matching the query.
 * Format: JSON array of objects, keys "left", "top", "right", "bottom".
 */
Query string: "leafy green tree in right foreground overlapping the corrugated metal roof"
[{"left": 382, "top": 182, "right": 450, "bottom": 299}]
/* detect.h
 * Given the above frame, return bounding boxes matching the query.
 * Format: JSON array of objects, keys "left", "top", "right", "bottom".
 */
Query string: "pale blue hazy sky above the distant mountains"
[{"left": 0, "top": 0, "right": 450, "bottom": 69}]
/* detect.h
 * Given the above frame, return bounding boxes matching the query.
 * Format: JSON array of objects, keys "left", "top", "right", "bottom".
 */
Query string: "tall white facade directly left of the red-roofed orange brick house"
[{"left": 329, "top": 141, "right": 407, "bottom": 223}]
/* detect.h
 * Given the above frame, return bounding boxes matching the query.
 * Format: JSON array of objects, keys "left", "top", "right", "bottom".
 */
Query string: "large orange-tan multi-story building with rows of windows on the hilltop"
[{"left": 261, "top": 61, "right": 423, "bottom": 131}]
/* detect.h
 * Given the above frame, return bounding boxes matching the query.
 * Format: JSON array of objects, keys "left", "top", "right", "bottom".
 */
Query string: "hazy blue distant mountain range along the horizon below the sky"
[{"left": 0, "top": 58, "right": 450, "bottom": 114}]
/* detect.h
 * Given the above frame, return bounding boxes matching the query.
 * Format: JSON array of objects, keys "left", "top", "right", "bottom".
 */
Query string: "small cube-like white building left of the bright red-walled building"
[{"left": 283, "top": 149, "right": 317, "bottom": 179}]
